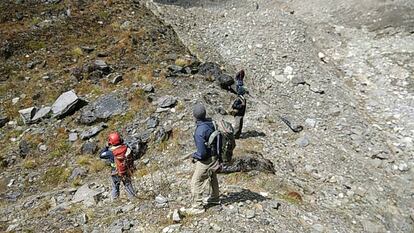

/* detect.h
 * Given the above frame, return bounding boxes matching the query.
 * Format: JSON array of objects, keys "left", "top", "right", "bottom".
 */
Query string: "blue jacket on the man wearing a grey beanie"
[{"left": 193, "top": 119, "right": 214, "bottom": 160}]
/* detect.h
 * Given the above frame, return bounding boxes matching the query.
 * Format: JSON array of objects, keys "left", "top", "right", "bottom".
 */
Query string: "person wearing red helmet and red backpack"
[{"left": 99, "top": 132, "right": 136, "bottom": 199}]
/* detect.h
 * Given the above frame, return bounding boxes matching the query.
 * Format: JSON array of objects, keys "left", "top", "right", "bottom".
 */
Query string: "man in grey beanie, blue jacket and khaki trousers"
[{"left": 187, "top": 104, "right": 220, "bottom": 214}]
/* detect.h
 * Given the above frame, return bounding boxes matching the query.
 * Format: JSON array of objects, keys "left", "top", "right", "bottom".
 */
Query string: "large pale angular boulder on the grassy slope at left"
[{"left": 52, "top": 90, "right": 81, "bottom": 118}]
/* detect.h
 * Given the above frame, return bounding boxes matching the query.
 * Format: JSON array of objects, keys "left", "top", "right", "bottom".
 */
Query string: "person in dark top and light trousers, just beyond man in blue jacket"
[{"left": 231, "top": 86, "right": 246, "bottom": 139}]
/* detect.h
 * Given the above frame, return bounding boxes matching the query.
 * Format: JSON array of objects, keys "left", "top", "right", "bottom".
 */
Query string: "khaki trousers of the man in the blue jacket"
[{"left": 191, "top": 157, "right": 220, "bottom": 207}]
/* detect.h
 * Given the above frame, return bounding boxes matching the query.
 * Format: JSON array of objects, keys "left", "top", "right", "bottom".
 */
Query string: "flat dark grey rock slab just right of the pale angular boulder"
[{"left": 79, "top": 94, "right": 128, "bottom": 125}]
